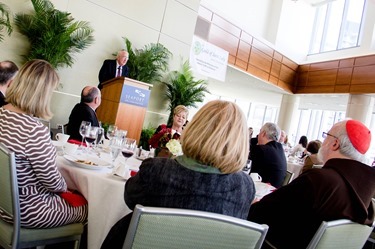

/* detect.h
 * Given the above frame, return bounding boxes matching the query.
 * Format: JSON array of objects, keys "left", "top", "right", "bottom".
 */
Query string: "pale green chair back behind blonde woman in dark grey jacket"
[{"left": 123, "top": 205, "right": 268, "bottom": 249}]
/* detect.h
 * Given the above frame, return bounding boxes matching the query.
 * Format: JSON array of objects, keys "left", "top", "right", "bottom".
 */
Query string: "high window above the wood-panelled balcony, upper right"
[{"left": 309, "top": 0, "right": 366, "bottom": 54}]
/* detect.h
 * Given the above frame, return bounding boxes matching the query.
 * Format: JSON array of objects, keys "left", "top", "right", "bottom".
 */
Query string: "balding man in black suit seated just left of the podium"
[{"left": 67, "top": 86, "right": 101, "bottom": 141}]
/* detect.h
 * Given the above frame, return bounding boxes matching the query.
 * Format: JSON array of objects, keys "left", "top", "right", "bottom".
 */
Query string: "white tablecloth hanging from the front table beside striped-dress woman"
[{"left": 57, "top": 154, "right": 141, "bottom": 249}]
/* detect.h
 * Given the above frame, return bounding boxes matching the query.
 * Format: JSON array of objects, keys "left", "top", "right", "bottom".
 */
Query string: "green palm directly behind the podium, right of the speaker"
[{"left": 124, "top": 38, "right": 172, "bottom": 84}]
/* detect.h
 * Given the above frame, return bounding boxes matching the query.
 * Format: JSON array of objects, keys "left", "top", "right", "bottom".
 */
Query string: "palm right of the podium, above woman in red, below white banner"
[{"left": 162, "top": 61, "right": 209, "bottom": 124}]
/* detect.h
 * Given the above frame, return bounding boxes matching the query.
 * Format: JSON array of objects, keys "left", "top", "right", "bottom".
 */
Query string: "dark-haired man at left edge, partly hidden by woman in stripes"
[{"left": 0, "top": 61, "right": 18, "bottom": 107}]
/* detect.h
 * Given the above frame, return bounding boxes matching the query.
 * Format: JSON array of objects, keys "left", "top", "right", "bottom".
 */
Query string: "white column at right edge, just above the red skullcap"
[{"left": 346, "top": 94, "right": 374, "bottom": 127}]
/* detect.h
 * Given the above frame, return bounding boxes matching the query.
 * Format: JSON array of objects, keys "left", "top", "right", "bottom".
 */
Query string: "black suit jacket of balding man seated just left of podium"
[{"left": 67, "top": 103, "right": 99, "bottom": 141}]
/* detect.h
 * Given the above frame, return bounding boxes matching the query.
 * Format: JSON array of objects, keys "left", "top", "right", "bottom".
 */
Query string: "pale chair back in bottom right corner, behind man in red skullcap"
[{"left": 307, "top": 219, "right": 375, "bottom": 249}]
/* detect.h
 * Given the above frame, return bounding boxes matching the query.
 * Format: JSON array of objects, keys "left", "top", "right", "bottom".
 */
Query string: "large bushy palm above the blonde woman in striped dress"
[{"left": 14, "top": 0, "right": 94, "bottom": 68}]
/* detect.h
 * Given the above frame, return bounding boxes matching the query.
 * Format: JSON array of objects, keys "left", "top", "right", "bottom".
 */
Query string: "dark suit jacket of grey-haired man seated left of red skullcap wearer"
[{"left": 251, "top": 141, "right": 287, "bottom": 188}]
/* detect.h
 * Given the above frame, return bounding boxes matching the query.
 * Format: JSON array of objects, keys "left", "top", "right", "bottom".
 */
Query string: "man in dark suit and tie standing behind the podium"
[{"left": 98, "top": 50, "right": 129, "bottom": 89}]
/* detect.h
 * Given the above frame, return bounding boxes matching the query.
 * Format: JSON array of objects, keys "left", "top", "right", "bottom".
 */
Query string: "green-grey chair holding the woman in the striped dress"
[{"left": 0, "top": 143, "right": 83, "bottom": 249}]
